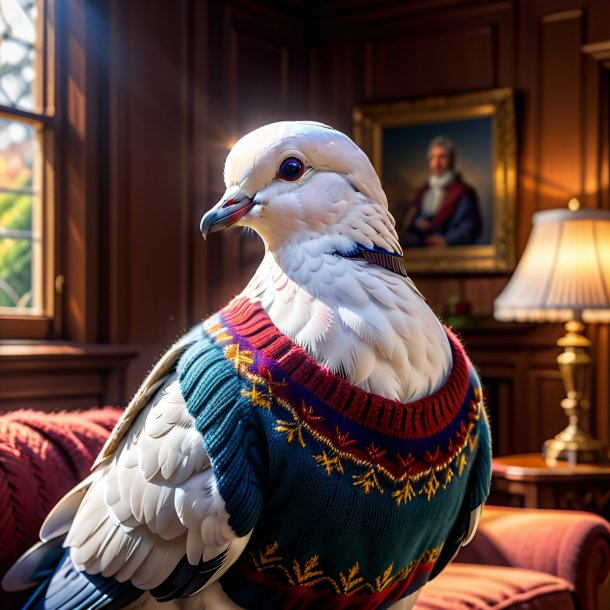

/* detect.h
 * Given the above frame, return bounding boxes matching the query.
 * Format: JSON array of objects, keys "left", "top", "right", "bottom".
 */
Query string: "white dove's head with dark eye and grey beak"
[{"left": 201, "top": 121, "right": 402, "bottom": 255}]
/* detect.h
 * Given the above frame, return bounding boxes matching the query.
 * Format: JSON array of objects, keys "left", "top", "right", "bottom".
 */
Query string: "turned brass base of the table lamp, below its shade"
[{"left": 542, "top": 320, "right": 608, "bottom": 465}]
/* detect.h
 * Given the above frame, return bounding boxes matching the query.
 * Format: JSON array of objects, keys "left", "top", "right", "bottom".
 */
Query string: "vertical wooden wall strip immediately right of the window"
[{"left": 58, "top": 0, "right": 101, "bottom": 342}]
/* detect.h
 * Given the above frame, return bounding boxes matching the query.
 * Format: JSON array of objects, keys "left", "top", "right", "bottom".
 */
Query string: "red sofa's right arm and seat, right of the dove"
[{"left": 415, "top": 506, "right": 610, "bottom": 610}]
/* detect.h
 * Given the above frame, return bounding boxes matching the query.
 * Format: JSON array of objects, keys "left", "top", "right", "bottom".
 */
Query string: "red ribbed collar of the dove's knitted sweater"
[{"left": 222, "top": 298, "right": 470, "bottom": 438}]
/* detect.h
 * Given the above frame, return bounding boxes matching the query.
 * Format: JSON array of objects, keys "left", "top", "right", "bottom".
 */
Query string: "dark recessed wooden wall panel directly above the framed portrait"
[{"left": 356, "top": 2, "right": 514, "bottom": 100}]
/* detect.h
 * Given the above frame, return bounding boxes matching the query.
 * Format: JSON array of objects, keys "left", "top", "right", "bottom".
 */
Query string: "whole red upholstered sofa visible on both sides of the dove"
[{"left": 0, "top": 407, "right": 610, "bottom": 610}]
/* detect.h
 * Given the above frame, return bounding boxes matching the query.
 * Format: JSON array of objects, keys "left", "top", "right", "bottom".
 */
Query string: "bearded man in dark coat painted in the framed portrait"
[{"left": 403, "top": 136, "right": 482, "bottom": 248}]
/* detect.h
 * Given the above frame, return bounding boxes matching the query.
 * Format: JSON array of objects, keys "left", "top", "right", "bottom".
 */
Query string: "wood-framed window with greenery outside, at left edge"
[{"left": 0, "top": 0, "right": 54, "bottom": 338}]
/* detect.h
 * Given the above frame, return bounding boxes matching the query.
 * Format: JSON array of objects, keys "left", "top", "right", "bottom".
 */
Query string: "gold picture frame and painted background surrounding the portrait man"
[{"left": 353, "top": 89, "right": 516, "bottom": 273}]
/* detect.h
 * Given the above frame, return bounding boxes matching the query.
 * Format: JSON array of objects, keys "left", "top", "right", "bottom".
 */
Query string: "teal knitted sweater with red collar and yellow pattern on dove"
[{"left": 179, "top": 299, "right": 491, "bottom": 610}]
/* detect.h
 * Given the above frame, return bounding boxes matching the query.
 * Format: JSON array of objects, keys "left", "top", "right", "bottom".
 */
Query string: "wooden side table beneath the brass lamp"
[{"left": 490, "top": 453, "right": 610, "bottom": 521}]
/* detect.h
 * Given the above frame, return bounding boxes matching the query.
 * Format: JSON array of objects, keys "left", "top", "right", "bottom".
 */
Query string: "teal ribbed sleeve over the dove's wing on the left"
[{"left": 178, "top": 334, "right": 265, "bottom": 536}]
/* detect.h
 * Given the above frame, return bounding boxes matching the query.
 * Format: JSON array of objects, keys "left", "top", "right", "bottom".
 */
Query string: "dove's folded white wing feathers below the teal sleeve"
[{"left": 66, "top": 374, "right": 249, "bottom": 589}]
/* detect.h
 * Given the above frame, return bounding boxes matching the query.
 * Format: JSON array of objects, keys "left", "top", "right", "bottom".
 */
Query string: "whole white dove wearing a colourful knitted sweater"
[{"left": 3, "top": 121, "right": 490, "bottom": 610}]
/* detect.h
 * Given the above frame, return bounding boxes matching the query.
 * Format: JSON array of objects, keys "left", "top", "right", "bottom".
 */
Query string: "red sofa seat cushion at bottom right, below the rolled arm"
[{"left": 415, "top": 563, "right": 576, "bottom": 610}]
